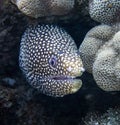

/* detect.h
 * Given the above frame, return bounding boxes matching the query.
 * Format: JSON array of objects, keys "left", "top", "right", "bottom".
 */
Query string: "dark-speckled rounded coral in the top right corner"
[{"left": 89, "top": 0, "right": 120, "bottom": 24}]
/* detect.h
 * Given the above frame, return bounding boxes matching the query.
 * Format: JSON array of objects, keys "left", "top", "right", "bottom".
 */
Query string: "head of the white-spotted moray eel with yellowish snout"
[{"left": 19, "top": 25, "right": 84, "bottom": 97}]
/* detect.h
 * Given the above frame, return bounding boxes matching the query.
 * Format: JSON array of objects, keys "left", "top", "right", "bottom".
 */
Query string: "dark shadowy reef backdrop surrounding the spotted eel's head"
[{"left": 0, "top": 0, "right": 120, "bottom": 125}]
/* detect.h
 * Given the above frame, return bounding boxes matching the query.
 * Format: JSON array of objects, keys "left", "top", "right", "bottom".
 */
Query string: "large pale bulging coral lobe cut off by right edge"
[{"left": 93, "top": 31, "right": 120, "bottom": 91}]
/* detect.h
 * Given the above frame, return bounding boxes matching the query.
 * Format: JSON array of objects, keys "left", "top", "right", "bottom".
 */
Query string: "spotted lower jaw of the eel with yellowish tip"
[{"left": 35, "top": 76, "right": 82, "bottom": 97}]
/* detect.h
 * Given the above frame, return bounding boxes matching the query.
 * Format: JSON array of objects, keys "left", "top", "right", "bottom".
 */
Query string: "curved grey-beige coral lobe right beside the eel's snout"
[{"left": 79, "top": 25, "right": 114, "bottom": 73}]
